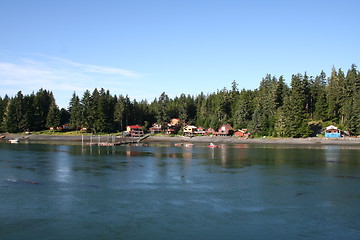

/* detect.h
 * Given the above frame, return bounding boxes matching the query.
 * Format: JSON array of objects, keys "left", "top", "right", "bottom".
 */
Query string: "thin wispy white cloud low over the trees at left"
[{"left": 0, "top": 55, "right": 141, "bottom": 106}]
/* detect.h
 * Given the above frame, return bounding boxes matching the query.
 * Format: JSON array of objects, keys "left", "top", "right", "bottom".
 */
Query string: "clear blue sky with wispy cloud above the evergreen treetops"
[{"left": 0, "top": 0, "right": 360, "bottom": 107}]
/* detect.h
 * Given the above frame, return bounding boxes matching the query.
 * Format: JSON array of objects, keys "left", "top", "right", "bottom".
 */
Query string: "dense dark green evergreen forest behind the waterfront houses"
[{"left": 0, "top": 64, "right": 360, "bottom": 137}]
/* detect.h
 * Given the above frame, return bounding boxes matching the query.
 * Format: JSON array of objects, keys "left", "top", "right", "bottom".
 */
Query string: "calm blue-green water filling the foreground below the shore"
[{"left": 0, "top": 143, "right": 360, "bottom": 240}]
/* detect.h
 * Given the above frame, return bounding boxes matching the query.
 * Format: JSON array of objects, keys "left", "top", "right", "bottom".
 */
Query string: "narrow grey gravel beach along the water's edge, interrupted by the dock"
[{"left": 0, "top": 133, "right": 360, "bottom": 146}]
